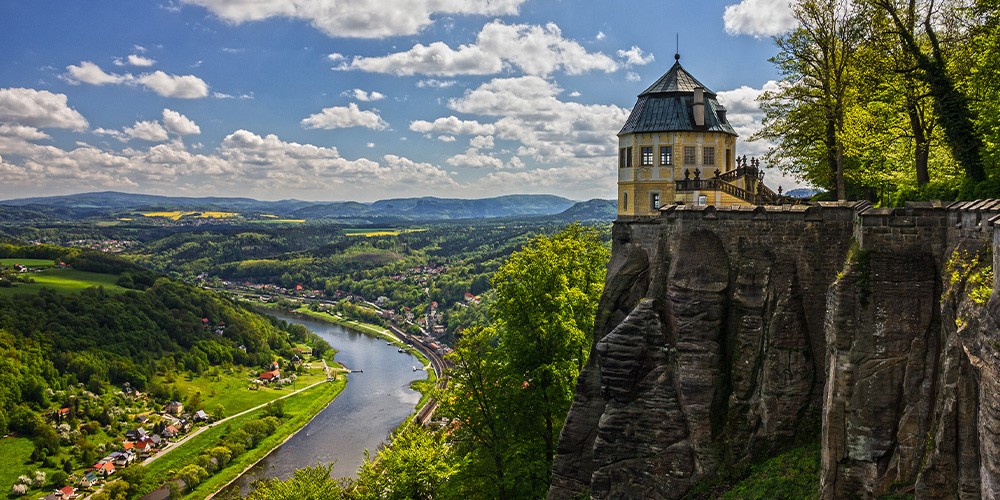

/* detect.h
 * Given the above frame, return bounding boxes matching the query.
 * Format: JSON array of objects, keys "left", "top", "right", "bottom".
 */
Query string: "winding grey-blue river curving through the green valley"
[{"left": 226, "top": 313, "right": 427, "bottom": 495}]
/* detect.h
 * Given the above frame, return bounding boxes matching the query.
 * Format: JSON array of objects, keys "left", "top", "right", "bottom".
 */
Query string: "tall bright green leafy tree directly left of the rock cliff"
[{"left": 451, "top": 224, "right": 609, "bottom": 498}]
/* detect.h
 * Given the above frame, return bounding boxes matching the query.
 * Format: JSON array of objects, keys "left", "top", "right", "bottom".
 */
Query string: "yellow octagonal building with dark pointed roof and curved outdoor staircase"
[{"left": 618, "top": 55, "right": 781, "bottom": 217}]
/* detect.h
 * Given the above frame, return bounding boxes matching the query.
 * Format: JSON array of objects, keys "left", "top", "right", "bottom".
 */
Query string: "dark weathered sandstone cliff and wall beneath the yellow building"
[{"left": 549, "top": 203, "right": 1000, "bottom": 498}]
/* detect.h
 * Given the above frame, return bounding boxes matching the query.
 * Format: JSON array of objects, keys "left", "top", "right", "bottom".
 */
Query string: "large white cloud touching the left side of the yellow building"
[{"left": 450, "top": 76, "right": 628, "bottom": 162}]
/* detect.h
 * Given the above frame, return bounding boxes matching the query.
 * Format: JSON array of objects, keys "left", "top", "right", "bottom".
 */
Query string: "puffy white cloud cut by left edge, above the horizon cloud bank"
[{"left": 0, "top": 88, "right": 87, "bottom": 131}]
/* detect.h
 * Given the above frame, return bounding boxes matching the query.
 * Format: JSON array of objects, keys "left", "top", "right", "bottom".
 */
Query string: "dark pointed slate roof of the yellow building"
[{"left": 618, "top": 57, "right": 738, "bottom": 135}]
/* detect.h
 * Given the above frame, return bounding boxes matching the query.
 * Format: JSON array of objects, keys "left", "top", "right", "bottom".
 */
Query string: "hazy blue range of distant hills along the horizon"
[{"left": 0, "top": 191, "right": 588, "bottom": 221}]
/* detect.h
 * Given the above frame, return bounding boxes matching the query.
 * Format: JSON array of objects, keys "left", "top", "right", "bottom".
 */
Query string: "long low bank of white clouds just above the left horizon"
[{"left": 0, "top": 122, "right": 458, "bottom": 199}]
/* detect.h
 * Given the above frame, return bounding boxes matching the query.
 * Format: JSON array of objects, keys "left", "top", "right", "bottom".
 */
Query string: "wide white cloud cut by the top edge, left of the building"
[{"left": 183, "top": 0, "right": 525, "bottom": 38}]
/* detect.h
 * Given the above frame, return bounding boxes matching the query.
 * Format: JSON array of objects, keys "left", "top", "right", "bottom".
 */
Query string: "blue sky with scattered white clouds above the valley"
[{"left": 0, "top": 0, "right": 800, "bottom": 201}]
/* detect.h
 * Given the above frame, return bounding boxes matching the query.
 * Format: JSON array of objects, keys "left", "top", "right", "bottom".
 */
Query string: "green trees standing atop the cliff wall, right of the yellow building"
[{"left": 751, "top": 0, "right": 1000, "bottom": 205}]
